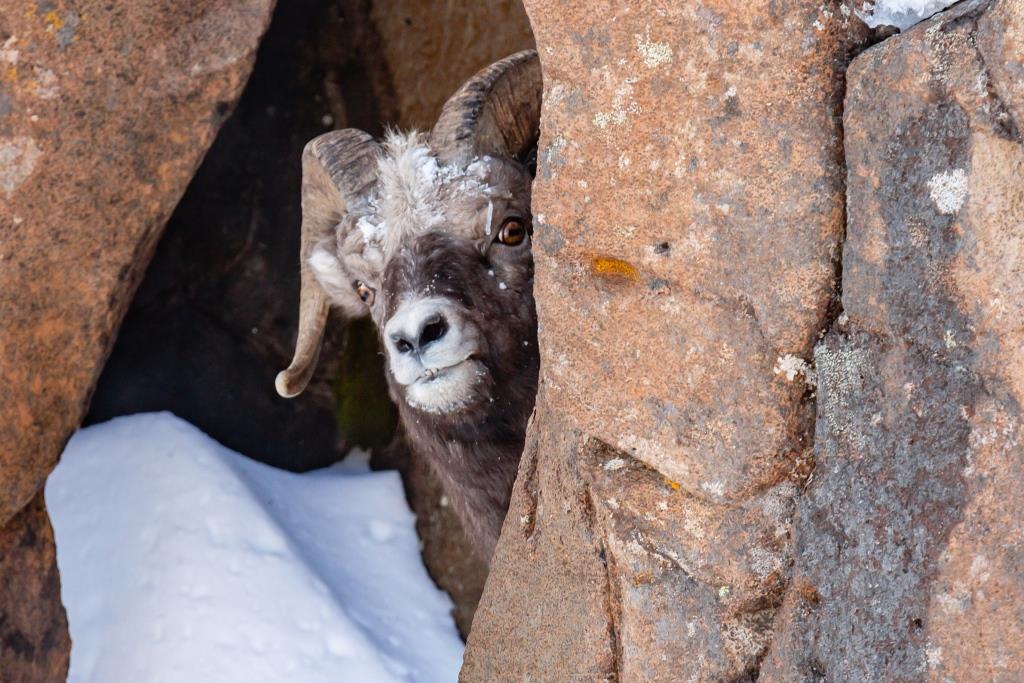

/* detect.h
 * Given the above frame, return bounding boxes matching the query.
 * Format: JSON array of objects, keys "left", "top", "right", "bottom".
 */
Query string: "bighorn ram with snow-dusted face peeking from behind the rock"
[{"left": 276, "top": 50, "right": 541, "bottom": 559}]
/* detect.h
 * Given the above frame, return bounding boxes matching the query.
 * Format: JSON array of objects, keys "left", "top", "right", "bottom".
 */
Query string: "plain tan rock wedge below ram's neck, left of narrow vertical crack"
[{"left": 459, "top": 393, "right": 617, "bottom": 683}]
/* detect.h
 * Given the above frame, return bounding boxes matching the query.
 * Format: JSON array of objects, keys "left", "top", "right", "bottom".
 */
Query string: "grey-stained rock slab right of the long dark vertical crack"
[{"left": 762, "top": 0, "right": 1024, "bottom": 681}]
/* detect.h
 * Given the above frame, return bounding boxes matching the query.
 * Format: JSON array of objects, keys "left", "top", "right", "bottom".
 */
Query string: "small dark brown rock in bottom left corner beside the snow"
[{"left": 0, "top": 492, "right": 71, "bottom": 683}]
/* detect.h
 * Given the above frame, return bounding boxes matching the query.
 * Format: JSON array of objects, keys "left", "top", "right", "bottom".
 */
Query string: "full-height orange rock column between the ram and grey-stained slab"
[{"left": 463, "top": 0, "right": 864, "bottom": 681}]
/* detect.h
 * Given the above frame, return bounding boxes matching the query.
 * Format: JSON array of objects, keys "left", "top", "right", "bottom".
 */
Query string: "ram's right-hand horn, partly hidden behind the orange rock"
[{"left": 430, "top": 50, "right": 543, "bottom": 162}]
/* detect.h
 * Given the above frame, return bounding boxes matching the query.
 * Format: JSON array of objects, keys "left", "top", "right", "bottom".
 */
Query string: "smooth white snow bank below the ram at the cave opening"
[{"left": 46, "top": 414, "right": 463, "bottom": 683}]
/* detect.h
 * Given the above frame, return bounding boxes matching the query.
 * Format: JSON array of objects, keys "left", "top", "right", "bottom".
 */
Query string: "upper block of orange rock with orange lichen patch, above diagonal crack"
[{"left": 527, "top": 2, "right": 855, "bottom": 502}]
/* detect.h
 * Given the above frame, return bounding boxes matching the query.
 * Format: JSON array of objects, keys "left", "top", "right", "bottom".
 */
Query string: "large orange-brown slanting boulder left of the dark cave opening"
[{"left": 0, "top": 0, "right": 272, "bottom": 524}]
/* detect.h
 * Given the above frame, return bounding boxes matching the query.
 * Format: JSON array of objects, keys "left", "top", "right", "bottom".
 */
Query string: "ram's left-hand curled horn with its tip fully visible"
[{"left": 274, "top": 128, "right": 378, "bottom": 398}]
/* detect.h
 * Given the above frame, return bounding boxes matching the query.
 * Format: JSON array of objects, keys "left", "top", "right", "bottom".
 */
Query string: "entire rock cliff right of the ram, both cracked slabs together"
[{"left": 463, "top": 0, "right": 1024, "bottom": 681}]
